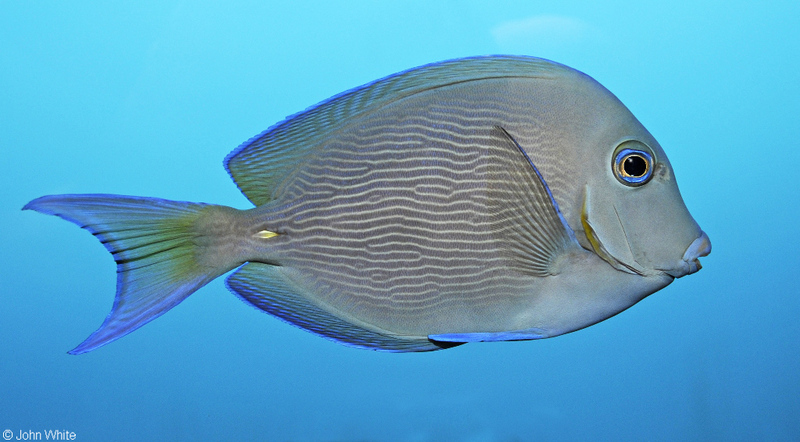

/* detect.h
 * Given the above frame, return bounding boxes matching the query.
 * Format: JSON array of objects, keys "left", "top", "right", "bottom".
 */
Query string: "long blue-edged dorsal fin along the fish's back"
[{"left": 225, "top": 56, "right": 574, "bottom": 205}]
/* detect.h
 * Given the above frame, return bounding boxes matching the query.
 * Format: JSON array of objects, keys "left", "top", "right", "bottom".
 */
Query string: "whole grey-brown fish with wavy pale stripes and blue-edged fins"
[{"left": 25, "top": 57, "right": 711, "bottom": 353}]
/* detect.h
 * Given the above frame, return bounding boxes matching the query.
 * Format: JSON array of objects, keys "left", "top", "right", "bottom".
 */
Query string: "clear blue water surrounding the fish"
[{"left": 0, "top": 0, "right": 800, "bottom": 441}]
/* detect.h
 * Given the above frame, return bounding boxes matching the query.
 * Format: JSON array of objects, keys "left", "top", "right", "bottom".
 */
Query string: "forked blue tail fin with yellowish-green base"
[{"left": 23, "top": 195, "right": 242, "bottom": 354}]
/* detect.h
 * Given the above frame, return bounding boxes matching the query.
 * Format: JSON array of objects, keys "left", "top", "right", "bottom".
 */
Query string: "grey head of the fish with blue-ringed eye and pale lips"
[{"left": 576, "top": 108, "right": 711, "bottom": 278}]
